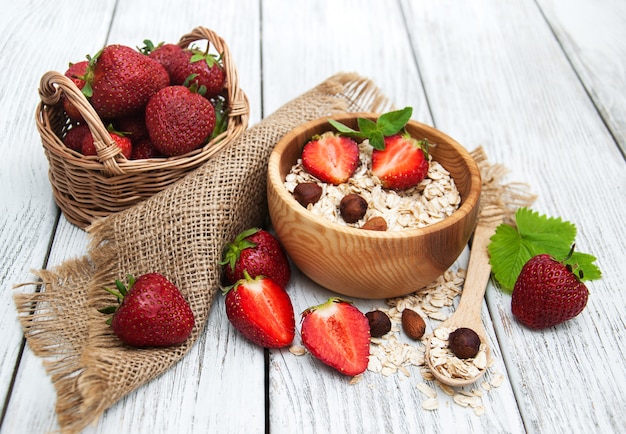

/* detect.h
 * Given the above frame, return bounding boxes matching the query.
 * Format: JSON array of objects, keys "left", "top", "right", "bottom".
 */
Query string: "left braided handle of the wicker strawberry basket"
[{"left": 39, "top": 71, "right": 125, "bottom": 175}]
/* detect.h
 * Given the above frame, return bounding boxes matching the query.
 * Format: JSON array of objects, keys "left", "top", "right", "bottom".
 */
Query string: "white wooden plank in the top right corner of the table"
[{"left": 538, "top": 0, "right": 626, "bottom": 154}]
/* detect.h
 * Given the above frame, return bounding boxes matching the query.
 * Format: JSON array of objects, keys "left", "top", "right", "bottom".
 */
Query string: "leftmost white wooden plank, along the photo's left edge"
[{"left": 0, "top": 1, "right": 114, "bottom": 418}]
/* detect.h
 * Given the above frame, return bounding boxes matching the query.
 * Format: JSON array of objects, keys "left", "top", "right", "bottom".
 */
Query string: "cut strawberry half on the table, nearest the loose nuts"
[{"left": 301, "top": 298, "right": 370, "bottom": 375}]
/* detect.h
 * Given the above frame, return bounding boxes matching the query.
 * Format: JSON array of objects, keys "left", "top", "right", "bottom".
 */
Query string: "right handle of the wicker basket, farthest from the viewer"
[{"left": 178, "top": 26, "right": 249, "bottom": 123}]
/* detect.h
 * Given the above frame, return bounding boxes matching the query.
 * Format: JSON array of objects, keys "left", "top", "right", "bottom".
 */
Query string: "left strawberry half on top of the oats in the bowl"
[{"left": 302, "top": 133, "right": 359, "bottom": 185}]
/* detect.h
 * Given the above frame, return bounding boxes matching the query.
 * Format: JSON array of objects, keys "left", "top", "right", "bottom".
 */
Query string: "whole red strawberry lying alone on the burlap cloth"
[{"left": 100, "top": 273, "right": 195, "bottom": 347}]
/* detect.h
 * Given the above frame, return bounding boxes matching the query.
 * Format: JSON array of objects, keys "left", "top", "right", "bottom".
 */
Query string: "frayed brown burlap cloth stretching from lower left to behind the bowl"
[{"left": 14, "top": 74, "right": 390, "bottom": 433}]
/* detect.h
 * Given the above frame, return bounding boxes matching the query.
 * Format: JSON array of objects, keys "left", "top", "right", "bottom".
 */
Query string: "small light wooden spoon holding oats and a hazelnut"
[{"left": 426, "top": 206, "right": 504, "bottom": 387}]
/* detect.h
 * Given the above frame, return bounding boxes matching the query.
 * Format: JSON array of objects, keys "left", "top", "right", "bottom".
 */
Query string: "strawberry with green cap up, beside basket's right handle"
[{"left": 170, "top": 47, "right": 226, "bottom": 98}]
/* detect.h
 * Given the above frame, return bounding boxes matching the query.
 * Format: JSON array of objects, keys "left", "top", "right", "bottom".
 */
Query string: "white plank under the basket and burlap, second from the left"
[{"left": 3, "top": 1, "right": 265, "bottom": 433}]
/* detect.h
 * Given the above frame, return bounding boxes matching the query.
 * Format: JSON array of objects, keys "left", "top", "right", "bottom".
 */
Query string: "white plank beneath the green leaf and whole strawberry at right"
[{"left": 403, "top": 1, "right": 626, "bottom": 432}]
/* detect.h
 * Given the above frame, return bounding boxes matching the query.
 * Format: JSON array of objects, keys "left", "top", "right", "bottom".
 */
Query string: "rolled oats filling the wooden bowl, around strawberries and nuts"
[{"left": 284, "top": 140, "right": 461, "bottom": 230}]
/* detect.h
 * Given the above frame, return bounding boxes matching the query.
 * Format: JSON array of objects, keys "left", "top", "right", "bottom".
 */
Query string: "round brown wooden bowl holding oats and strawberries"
[{"left": 267, "top": 113, "right": 481, "bottom": 299}]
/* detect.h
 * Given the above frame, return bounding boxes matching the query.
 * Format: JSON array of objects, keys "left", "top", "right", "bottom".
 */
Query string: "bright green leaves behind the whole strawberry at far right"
[{"left": 488, "top": 208, "right": 601, "bottom": 293}]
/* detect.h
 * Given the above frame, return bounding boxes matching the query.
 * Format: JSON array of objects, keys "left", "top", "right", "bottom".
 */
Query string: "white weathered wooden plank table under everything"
[{"left": 0, "top": 0, "right": 626, "bottom": 434}]
